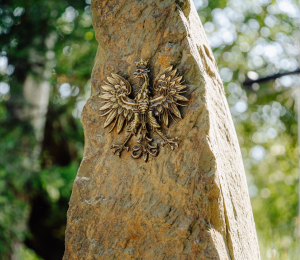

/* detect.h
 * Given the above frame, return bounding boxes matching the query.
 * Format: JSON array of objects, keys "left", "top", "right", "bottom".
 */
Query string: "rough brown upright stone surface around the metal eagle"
[{"left": 64, "top": 0, "right": 260, "bottom": 260}]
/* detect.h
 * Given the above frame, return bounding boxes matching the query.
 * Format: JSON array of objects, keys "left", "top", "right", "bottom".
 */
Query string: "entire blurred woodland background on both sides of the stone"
[{"left": 0, "top": 0, "right": 300, "bottom": 260}]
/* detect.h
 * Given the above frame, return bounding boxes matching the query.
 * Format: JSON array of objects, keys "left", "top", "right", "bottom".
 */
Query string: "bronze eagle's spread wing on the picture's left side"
[{"left": 99, "top": 73, "right": 137, "bottom": 133}]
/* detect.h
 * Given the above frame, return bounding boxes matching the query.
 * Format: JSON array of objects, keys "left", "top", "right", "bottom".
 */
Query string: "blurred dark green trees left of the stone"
[{"left": 0, "top": 0, "right": 97, "bottom": 260}]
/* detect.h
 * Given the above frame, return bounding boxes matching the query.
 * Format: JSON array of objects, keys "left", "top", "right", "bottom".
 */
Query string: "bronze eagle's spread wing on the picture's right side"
[{"left": 149, "top": 66, "right": 188, "bottom": 126}]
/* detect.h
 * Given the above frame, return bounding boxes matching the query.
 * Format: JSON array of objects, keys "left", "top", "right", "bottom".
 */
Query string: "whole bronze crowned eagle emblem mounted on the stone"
[{"left": 99, "top": 60, "right": 188, "bottom": 162}]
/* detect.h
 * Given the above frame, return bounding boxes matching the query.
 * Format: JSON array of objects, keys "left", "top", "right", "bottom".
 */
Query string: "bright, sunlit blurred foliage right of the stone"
[{"left": 198, "top": 0, "right": 300, "bottom": 259}]
